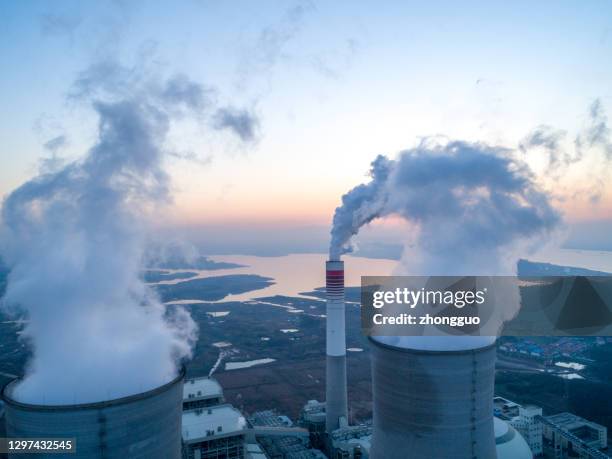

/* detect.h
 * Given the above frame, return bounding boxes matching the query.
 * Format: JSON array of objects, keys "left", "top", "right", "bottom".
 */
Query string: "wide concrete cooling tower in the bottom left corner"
[{"left": 2, "top": 370, "right": 185, "bottom": 459}]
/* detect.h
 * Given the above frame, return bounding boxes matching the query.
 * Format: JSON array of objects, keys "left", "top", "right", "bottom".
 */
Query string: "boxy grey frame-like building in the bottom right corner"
[{"left": 541, "top": 413, "right": 608, "bottom": 459}]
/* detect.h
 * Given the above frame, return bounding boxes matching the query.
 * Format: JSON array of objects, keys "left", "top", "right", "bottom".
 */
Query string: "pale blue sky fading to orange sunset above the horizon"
[{"left": 0, "top": 0, "right": 612, "bottom": 255}]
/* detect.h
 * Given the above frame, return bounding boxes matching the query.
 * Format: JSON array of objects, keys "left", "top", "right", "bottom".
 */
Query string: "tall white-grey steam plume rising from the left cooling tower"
[{"left": 0, "top": 62, "right": 253, "bottom": 404}]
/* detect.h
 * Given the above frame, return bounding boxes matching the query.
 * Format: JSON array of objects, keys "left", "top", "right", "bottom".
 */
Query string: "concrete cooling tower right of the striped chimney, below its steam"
[{"left": 370, "top": 338, "right": 496, "bottom": 459}]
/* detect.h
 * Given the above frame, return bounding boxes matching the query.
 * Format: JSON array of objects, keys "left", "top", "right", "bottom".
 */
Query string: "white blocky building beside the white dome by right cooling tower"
[{"left": 493, "top": 397, "right": 544, "bottom": 457}]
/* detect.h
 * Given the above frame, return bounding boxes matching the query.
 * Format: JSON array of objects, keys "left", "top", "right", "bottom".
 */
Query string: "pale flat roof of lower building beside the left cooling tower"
[{"left": 182, "top": 405, "right": 246, "bottom": 442}]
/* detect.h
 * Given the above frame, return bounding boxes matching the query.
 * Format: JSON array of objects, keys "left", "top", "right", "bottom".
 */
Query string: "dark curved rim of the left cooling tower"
[{"left": 0, "top": 366, "right": 186, "bottom": 411}]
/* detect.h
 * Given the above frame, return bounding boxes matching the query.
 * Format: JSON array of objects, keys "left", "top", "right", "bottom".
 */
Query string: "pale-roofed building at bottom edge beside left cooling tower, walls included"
[{"left": 182, "top": 405, "right": 247, "bottom": 459}]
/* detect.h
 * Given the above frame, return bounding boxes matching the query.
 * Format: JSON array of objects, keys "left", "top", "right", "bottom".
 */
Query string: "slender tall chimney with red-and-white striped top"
[{"left": 325, "top": 261, "right": 348, "bottom": 433}]
